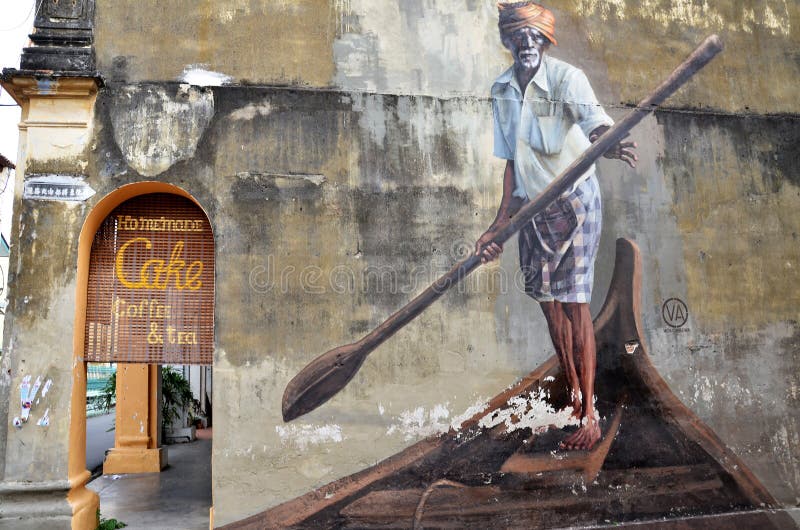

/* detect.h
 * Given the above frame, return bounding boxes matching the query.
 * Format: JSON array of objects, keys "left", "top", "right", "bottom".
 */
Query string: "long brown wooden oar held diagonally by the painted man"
[{"left": 283, "top": 35, "right": 722, "bottom": 421}]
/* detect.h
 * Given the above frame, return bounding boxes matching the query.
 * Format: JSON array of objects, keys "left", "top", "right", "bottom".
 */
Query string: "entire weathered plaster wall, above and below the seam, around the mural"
[{"left": 2, "top": 0, "right": 800, "bottom": 524}]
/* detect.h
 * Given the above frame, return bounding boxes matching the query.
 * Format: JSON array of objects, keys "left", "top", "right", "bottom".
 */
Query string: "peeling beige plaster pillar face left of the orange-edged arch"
[{"left": 3, "top": 198, "right": 82, "bottom": 482}]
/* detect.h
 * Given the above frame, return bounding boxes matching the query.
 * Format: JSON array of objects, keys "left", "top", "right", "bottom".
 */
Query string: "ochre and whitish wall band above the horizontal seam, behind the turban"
[{"left": 96, "top": 0, "right": 800, "bottom": 113}]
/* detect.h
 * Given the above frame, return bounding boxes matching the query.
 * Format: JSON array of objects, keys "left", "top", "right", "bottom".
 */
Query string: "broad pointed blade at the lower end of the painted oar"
[{"left": 282, "top": 344, "right": 369, "bottom": 422}]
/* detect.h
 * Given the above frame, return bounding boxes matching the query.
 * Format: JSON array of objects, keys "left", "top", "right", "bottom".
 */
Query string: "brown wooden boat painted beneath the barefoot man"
[{"left": 225, "top": 239, "right": 797, "bottom": 529}]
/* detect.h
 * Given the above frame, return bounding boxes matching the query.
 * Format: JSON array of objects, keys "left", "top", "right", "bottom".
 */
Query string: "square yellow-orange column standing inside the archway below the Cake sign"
[{"left": 103, "top": 364, "right": 167, "bottom": 475}]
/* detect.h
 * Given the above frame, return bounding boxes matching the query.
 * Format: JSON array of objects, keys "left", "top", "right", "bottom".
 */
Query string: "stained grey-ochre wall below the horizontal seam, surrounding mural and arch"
[{"left": 95, "top": 85, "right": 798, "bottom": 523}]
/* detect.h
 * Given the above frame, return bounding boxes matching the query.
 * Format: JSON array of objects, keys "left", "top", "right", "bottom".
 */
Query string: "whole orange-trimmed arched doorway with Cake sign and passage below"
[{"left": 69, "top": 182, "right": 215, "bottom": 528}]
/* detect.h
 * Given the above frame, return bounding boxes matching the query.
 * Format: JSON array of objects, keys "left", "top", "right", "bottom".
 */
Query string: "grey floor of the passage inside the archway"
[{"left": 88, "top": 433, "right": 211, "bottom": 530}]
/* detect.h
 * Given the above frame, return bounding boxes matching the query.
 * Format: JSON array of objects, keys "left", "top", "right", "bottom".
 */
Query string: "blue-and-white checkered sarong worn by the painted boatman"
[{"left": 519, "top": 174, "right": 603, "bottom": 303}]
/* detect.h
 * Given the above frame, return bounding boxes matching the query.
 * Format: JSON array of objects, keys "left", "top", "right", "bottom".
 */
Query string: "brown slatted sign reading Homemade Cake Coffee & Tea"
[{"left": 85, "top": 193, "right": 214, "bottom": 364}]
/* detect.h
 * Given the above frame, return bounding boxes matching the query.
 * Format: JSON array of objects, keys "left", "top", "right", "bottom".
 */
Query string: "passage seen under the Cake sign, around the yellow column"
[{"left": 86, "top": 363, "right": 213, "bottom": 529}]
